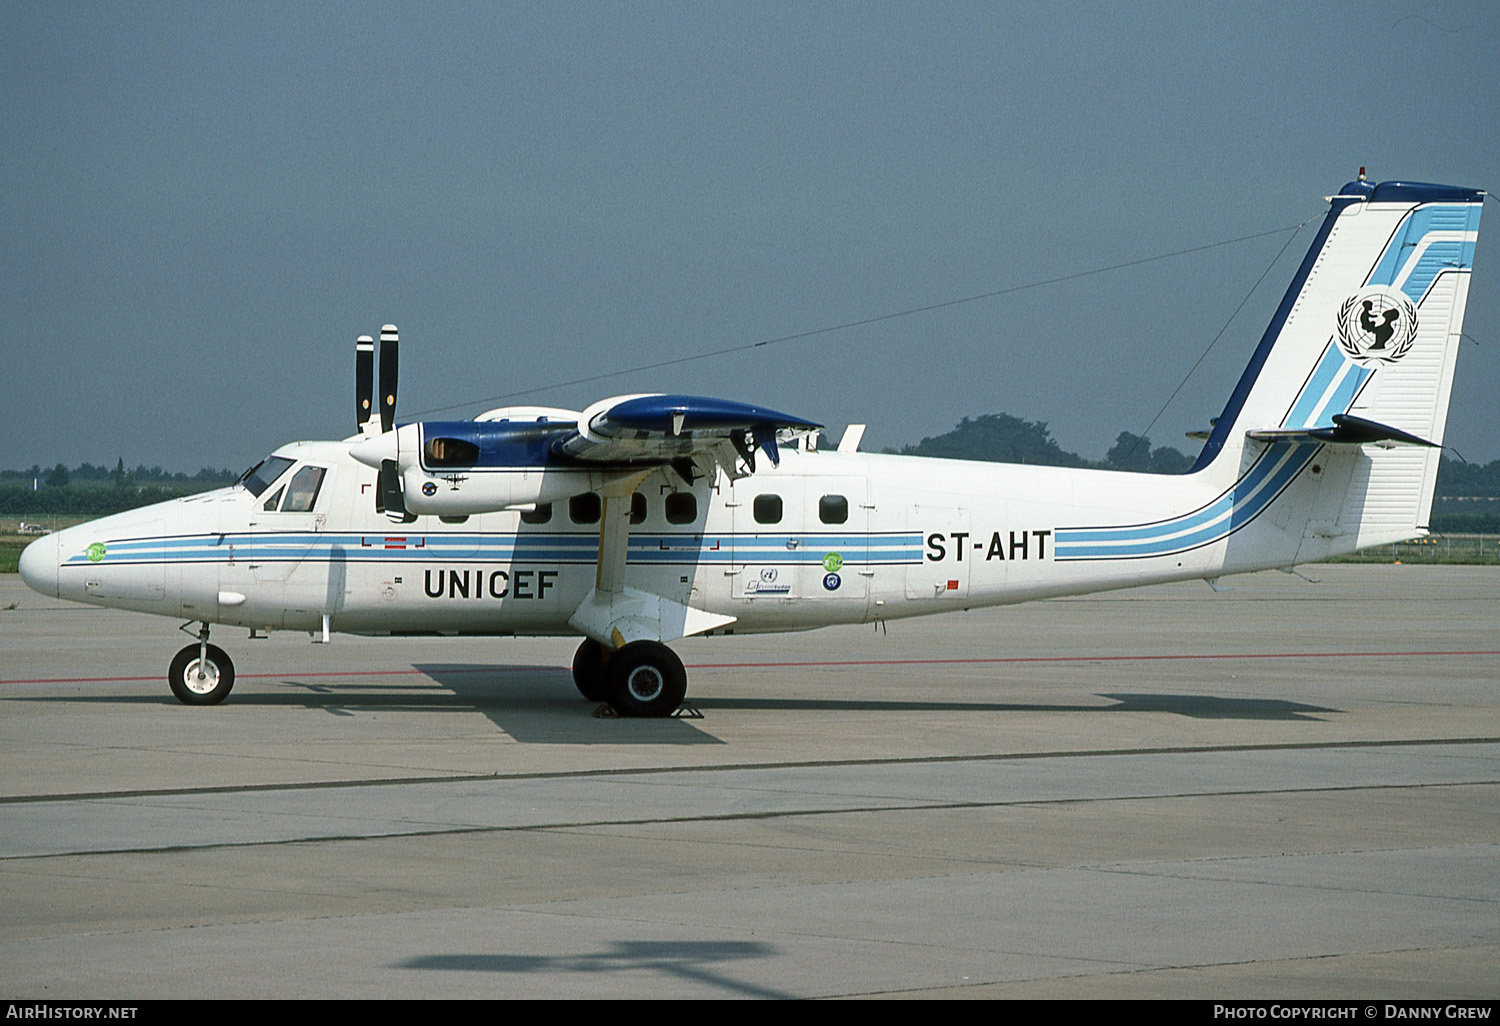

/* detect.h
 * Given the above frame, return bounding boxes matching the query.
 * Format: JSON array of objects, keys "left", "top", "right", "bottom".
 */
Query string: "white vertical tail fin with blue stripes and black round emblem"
[{"left": 1194, "top": 182, "right": 1485, "bottom": 563}]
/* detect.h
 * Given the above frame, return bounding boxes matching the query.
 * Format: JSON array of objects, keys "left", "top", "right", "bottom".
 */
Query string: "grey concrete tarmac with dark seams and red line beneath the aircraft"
[{"left": 0, "top": 566, "right": 1500, "bottom": 1001}]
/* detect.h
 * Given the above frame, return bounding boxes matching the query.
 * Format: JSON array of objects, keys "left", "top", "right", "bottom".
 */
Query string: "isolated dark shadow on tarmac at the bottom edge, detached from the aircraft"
[{"left": 396, "top": 941, "right": 797, "bottom": 998}]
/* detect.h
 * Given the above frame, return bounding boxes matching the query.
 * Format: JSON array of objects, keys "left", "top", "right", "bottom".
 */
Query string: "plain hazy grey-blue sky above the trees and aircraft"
[{"left": 0, "top": 0, "right": 1500, "bottom": 471}]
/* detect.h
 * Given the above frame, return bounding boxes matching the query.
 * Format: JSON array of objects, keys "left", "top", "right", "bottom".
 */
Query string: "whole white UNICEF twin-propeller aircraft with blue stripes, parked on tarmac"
[{"left": 21, "top": 176, "right": 1484, "bottom": 716}]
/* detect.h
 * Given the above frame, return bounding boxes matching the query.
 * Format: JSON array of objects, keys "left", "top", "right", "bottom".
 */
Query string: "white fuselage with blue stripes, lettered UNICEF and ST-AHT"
[{"left": 23, "top": 443, "right": 1374, "bottom": 635}]
